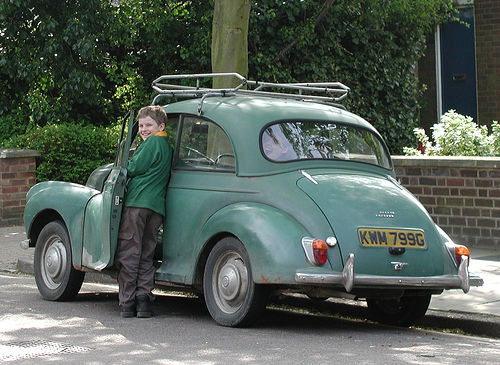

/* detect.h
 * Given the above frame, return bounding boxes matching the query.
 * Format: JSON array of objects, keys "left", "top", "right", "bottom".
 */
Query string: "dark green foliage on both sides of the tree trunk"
[{"left": 0, "top": 0, "right": 453, "bottom": 181}]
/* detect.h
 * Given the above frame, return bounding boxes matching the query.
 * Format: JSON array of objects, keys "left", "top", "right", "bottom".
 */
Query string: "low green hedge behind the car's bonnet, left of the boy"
[{"left": 2, "top": 123, "right": 120, "bottom": 184}]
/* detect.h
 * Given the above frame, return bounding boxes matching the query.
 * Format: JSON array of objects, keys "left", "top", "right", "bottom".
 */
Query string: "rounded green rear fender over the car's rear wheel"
[{"left": 200, "top": 202, "right": 320, "bottom": 284}]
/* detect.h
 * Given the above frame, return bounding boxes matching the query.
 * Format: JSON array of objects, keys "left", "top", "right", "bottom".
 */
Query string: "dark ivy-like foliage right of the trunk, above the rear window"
[{"left": 249, "top": 0, "right": 453, "bottom": 153}]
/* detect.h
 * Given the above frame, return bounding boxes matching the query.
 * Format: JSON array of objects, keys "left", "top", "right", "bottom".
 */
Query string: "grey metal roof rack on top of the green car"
[{"left": 151, "top": 72, "right": 351, "bottom": 115}]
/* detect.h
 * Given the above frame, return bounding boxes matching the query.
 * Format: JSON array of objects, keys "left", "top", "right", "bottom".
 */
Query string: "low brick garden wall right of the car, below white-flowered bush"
[{"left": 393, "top": 156, "right": 500, "bottom": 247}]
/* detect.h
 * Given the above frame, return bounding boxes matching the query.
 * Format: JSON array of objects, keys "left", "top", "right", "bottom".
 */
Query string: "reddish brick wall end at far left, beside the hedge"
[{"left": 0, "top": 150, "right": 39, "bottom": 226}]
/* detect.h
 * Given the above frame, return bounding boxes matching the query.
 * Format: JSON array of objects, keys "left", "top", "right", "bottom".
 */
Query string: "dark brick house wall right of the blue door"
[{"left": 474, "top": 0, "right": 500, "bottom": 124}]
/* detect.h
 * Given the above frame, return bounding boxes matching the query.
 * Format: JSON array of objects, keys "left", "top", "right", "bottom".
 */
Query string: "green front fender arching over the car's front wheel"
[{"left": 24, "top": 181, "right": 99, "bottom": 268}]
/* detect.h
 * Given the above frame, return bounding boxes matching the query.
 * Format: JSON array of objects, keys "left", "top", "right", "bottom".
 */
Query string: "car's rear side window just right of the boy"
[{"left": 175, "top": 117, "right": 236, "bottom": 172}]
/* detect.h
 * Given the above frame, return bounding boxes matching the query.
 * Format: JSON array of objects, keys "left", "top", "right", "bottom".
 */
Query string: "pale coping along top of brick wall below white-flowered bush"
[{"left": 391, "top": 156, "right": 500, "bottom": 169}]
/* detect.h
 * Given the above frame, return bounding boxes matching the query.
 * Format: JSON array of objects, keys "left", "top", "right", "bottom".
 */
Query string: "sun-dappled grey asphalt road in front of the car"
[{"left": 0, "top": 274, "right": 500, "bottom": 365}]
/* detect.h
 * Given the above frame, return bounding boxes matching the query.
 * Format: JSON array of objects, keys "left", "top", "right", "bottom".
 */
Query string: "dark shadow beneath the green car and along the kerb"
[{"left": 69, "top": 290, "right": 500, "bottom": 338}]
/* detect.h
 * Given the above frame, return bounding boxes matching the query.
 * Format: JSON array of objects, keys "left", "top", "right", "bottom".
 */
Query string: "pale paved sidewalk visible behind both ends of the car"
[{"left": 0, "top": 226, "right": 500, "bottom": 325}]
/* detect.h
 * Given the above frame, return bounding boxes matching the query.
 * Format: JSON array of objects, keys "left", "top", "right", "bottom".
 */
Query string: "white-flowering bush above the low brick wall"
[{"left": 403, "top": 110, "right": 500, "bottom": 156}]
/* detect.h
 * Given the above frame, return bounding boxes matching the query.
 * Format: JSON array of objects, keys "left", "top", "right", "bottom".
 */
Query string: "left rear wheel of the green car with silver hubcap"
[{"left": 203, "top": 237, "right": 268, "bottom": 327}]
